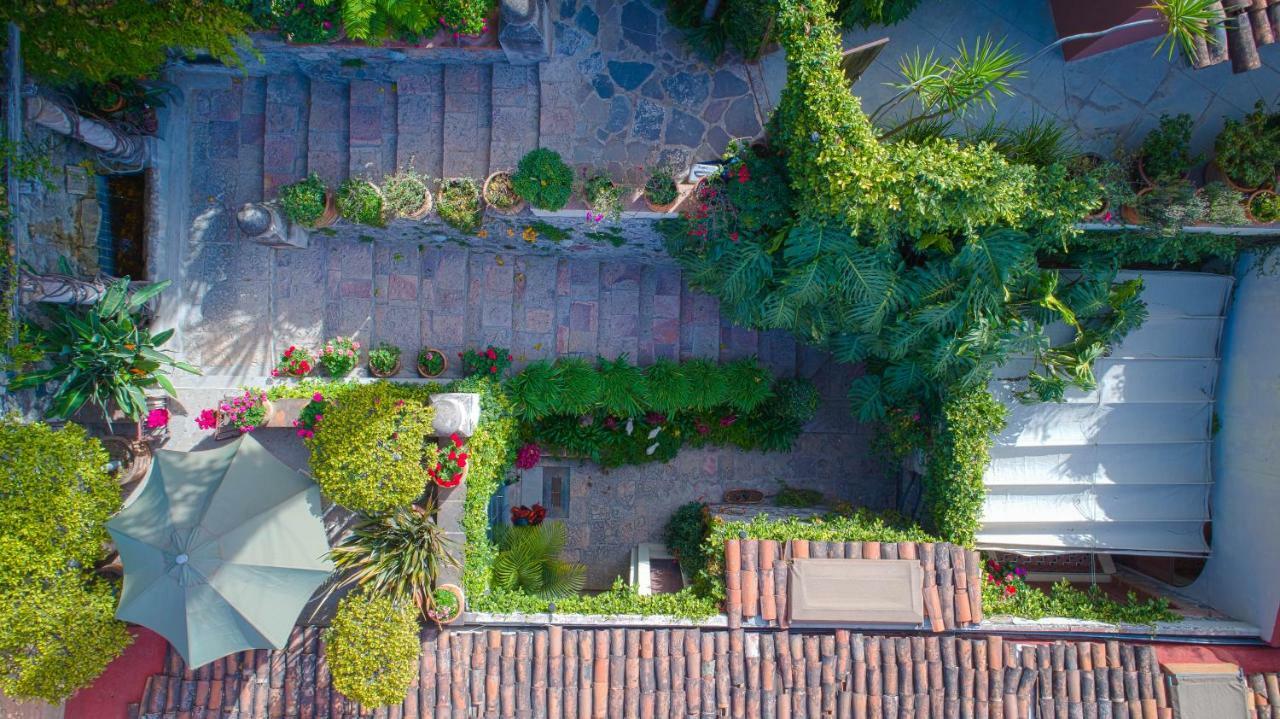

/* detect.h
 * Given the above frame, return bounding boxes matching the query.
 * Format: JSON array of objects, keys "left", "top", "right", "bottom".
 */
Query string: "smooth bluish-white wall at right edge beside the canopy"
[{"left": 1188, "top": 257, "right": 1280, "bottom": 640}]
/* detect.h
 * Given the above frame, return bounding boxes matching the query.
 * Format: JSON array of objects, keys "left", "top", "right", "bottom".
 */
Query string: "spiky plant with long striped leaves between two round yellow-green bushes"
[{"left": 329, "top": 500, "right": 461, "bottom": 617}]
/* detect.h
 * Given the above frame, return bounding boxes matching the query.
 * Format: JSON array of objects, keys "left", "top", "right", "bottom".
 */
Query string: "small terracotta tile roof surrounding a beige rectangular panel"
[{"left": 724, "top": 540, "right": 982, "bottom": 632}]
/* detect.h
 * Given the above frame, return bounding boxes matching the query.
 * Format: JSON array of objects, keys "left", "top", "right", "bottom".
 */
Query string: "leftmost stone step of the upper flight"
[{"left": 262, "top": 73, "right": 310, "bottom": 197}]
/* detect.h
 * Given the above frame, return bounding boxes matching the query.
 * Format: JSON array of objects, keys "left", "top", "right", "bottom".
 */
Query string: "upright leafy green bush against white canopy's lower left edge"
[{"left": 923, "top": 386, "right": 1005, "bottom": 546}]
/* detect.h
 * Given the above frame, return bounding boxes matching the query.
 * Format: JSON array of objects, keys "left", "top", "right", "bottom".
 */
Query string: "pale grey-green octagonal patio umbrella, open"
[{"left": 106, "top": 435, "right": 333, "bottom": 668}]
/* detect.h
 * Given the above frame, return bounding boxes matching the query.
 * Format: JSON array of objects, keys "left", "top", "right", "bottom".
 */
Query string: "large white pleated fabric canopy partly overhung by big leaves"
[{"left": 978, "top": 273, "right": 1231, "bottom": 555}]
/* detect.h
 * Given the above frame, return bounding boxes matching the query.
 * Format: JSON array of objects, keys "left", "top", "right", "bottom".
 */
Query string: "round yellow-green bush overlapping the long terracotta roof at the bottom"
[{"left": 324, "top": 592, "right": 422, "bottom": 707}]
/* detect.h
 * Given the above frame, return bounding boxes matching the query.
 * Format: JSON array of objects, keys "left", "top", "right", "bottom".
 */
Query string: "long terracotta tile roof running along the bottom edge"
[{"left": 138, "top": 627, "right": 1177, "bottom": 719}]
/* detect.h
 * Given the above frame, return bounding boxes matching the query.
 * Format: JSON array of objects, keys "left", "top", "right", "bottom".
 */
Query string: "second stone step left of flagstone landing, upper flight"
[{"left": 440, "top": 65, "right": 493, "bottom": 180}]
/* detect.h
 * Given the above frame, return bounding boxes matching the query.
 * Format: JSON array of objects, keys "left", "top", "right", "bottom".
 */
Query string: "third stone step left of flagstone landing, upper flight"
[{"left": 396, "top": 65, "right": 444, "bottom": 178}]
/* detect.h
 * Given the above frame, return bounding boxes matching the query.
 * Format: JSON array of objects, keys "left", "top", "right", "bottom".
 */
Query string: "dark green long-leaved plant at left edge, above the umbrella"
[{"left": 10, "top": 278, "right": 200, "bottom": 421}]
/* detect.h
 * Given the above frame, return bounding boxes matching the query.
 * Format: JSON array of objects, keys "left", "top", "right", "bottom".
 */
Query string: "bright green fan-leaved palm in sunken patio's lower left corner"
[{"left": 493, "top": 522, "right": 586, "bottom": 599}]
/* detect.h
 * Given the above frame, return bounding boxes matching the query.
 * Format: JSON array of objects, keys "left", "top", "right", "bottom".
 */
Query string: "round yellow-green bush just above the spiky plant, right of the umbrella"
[{"left": 306, "top": 383, "right": 434, "bottom": 513}]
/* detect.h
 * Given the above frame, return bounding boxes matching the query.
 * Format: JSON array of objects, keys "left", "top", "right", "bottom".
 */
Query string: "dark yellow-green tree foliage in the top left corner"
[{"left": 0, "top": 0, "right": 250, "bottom": 86}]
